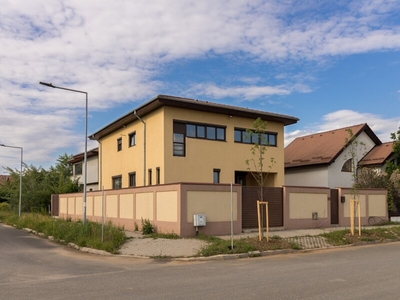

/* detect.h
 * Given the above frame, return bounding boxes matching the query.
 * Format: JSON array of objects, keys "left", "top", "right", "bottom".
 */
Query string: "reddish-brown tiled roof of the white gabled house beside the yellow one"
[{"left": 285, "top": 123, "right": 382, "bottom": 168}]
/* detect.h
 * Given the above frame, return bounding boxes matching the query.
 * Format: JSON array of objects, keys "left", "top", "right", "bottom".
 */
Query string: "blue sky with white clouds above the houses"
[{"left": 0, "top": 0, "right": 400, "bottom": 174}]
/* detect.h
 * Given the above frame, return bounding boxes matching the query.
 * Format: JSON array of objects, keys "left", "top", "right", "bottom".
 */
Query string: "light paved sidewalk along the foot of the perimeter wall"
[{"left": 120, "top": 227, "right": 345, "bottom": 258}]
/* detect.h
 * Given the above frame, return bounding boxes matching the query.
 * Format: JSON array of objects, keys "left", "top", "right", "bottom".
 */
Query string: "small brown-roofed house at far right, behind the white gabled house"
[{"left": 359, "top": 142, "right": 396, "bottom": 172}]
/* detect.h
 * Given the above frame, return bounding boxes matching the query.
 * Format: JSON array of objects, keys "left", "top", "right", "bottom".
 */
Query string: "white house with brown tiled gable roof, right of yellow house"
[{"left": 285, "top": 124, "right": 382, "bottom": 188}]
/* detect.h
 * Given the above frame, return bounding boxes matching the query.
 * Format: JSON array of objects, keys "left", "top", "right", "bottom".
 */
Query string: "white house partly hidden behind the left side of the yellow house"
[{"left": 68, "top": 148, "right": 99, "bottom": 191}]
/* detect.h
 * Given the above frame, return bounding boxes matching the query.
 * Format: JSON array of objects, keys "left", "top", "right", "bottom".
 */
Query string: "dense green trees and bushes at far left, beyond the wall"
[{"left": 0, "top": 154, "right": 79, "bottom": 212}]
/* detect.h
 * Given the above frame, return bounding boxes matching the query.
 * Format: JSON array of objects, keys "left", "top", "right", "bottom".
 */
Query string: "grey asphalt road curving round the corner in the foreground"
[{"left": 0, "top": 224, "right": 400, "bottom": 300}]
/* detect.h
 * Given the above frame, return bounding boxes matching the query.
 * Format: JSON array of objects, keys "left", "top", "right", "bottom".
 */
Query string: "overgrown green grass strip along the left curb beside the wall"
[{"left": 0, "top": 212, "right": 126, "bottom": 253}]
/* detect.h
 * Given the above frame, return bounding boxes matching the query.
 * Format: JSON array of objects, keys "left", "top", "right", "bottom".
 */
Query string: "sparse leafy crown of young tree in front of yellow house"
[{"left": 246, "top": 118, "right": 276, "bottom": 201}]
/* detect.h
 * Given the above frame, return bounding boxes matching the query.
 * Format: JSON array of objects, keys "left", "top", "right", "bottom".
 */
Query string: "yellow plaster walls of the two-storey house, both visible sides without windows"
[{"left": 99, "top": 106, "right": 284, "bottom": 189}]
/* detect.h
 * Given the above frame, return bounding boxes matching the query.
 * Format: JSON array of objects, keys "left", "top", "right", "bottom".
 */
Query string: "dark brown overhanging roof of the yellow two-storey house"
[{"left": 89, "top": 95, "right": 299, "bottom": 140}]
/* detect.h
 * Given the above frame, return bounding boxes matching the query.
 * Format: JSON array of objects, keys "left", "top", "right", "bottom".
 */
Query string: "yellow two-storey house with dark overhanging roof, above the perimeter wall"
[{"left": 90, "top": 95, "right": 298, "bottom": 189}]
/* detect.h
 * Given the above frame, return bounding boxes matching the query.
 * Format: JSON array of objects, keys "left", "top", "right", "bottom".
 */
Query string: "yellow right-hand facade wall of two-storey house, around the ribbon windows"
[{"left": 164, "top": 107, "right": 284, "bottom": 186}]
